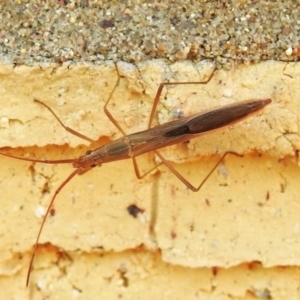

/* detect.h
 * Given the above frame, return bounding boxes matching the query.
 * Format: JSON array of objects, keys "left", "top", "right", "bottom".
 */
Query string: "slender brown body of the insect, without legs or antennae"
[{"left": 73, "top": 99, "right": 271, "bottom": 170}]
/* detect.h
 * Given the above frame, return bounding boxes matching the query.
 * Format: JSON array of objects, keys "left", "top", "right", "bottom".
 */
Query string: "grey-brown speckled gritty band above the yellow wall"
[{"left": 0, "top": 0, "right": 300, "bottom": 68}]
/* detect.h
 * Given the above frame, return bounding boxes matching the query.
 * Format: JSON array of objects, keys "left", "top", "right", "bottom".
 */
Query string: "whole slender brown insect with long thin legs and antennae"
[{"left": 0, "top": 66, "right": 271, "bottom": 286}]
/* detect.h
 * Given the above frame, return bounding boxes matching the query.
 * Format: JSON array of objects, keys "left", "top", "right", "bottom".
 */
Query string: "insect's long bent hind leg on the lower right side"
[{"left": 154, "top": 151, "right": 243, "bottom": 192}]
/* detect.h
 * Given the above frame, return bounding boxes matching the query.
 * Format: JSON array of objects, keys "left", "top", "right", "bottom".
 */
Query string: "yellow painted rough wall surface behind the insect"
[{"left": 0, "top": 60, "right": 300, "bottom": 299}]
